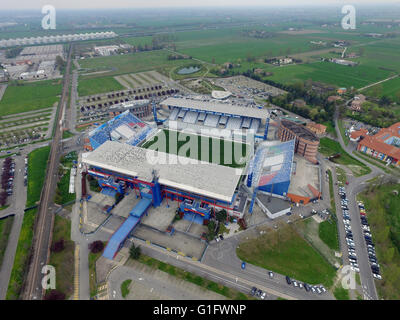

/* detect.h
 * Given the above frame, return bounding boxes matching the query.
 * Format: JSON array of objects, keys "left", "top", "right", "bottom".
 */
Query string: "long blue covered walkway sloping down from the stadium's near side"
[{"left": 103, "top": 198, "right": 152, "bottom": 260}]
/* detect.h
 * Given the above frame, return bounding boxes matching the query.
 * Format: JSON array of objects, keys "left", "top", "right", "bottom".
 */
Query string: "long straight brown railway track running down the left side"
[{"left": 22, "top": 44, "right": 72, "bottom": 300}]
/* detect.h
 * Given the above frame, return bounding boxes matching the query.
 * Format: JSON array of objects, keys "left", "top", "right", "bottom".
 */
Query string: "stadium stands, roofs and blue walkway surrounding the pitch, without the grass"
[{"left": 82, "top": 97, "right": 304, "bottom": 259}]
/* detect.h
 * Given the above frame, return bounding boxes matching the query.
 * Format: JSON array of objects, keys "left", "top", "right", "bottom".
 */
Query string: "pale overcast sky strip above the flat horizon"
[{"left": 0, "top": 0, "right": 399, "bottom": 10}]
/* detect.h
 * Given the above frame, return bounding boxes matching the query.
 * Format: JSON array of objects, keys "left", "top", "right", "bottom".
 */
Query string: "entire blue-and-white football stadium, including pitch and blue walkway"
[{"left": 82, "top": 97, "right": 318, "bottom": 259}]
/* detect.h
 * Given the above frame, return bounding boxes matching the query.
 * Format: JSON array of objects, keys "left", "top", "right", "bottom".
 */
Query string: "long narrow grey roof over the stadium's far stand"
[{"left": 161, "top": 97, "right": 269, "bottom": 119}]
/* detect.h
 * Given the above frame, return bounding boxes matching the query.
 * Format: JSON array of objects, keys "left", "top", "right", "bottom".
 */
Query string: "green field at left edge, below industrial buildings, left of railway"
[{"left": 0, "top": 80, "right": 61, "bottom": 117}]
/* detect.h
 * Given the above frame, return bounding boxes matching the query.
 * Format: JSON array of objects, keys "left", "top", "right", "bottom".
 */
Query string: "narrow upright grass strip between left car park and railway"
[{"left": 26, "top": 146, "right": 50, "bottom": 207}]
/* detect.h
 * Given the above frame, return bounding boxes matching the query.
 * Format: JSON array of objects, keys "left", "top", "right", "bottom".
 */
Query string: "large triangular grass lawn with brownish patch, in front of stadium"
[{"left": 236, "top": 225, "right": 336, "bottom": 287}]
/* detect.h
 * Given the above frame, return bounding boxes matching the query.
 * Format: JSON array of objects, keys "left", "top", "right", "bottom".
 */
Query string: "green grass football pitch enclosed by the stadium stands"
[{"left": 142, "top": 130, "right": 250, "bottom": 168}]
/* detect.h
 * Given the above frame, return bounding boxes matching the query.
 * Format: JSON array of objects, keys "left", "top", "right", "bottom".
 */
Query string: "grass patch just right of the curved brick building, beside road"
[{"left": 319, "top": 138, "right": 371, "bottom": 177}]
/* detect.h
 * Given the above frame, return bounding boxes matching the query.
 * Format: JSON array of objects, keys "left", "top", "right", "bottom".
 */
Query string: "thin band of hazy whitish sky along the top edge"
[{"left": 0, "top": 0, "right": 400, "bottom": 11}]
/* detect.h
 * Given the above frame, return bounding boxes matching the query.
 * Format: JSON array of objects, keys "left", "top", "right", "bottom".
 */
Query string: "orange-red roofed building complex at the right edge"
[{"left": 357, "top": 122, "right": 400, "bottom": 166}]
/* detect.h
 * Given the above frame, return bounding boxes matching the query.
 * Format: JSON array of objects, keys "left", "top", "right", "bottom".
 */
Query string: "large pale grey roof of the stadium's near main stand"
[{"left": 82, "top": 141, "right": 243, "bottom": 202}]
